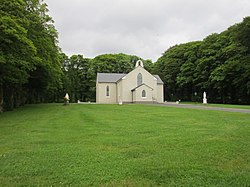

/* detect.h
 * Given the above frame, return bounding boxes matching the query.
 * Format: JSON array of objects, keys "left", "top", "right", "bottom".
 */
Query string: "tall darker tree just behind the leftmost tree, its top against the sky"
[{"left": 27, "top": 0, "right": 62, "bottom": 102}]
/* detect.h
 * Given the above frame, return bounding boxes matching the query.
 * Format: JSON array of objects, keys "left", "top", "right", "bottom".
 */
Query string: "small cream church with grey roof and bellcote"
[{"left": 96, "top": 60, "right": 164, "bottom": 103}]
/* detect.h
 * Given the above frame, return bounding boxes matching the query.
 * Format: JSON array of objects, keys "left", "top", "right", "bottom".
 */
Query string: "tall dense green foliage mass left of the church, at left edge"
[{"left": 0, "top": 0, "right": 62, "bottom": 111}]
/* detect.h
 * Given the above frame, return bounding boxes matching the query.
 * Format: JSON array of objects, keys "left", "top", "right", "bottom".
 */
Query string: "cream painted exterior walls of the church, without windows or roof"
[{"left": 96, "top": 66, "right": 163, "bottom": 103}]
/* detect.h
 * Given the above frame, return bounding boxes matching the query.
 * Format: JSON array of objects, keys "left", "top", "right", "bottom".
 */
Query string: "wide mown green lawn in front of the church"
[{"left": 0, "top": 104, "right": 250, "bottom": 187}]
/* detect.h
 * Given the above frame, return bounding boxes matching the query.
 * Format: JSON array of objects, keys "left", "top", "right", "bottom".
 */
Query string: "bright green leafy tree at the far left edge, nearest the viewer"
[{"left": 0, "top": 0, "right": 36, "bottom": 111}]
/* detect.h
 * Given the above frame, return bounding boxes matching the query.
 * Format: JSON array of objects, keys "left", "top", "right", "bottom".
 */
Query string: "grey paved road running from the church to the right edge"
[{"left": 157, "top": 102, "right": 250, "bottom": 113}]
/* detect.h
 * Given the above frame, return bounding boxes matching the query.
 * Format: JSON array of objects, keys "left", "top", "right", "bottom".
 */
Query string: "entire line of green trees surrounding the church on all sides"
[{"left": 0, "top": 0, "right": 250, "bottom": 111}]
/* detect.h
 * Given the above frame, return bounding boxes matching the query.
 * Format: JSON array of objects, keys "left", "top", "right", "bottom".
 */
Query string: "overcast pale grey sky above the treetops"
[{"left": 44, "top": 0, "right": 250, "bottom": 62}]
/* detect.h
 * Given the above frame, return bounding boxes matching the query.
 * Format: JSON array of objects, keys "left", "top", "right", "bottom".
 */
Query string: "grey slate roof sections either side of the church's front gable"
[{"left": 97, "top": 73, "right": 164, "bottom": 84}]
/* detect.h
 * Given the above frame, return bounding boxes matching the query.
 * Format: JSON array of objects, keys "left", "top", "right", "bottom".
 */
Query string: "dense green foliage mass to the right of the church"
[{"left": 154, "top": 17, "right": 250, "bottom": 104}]
